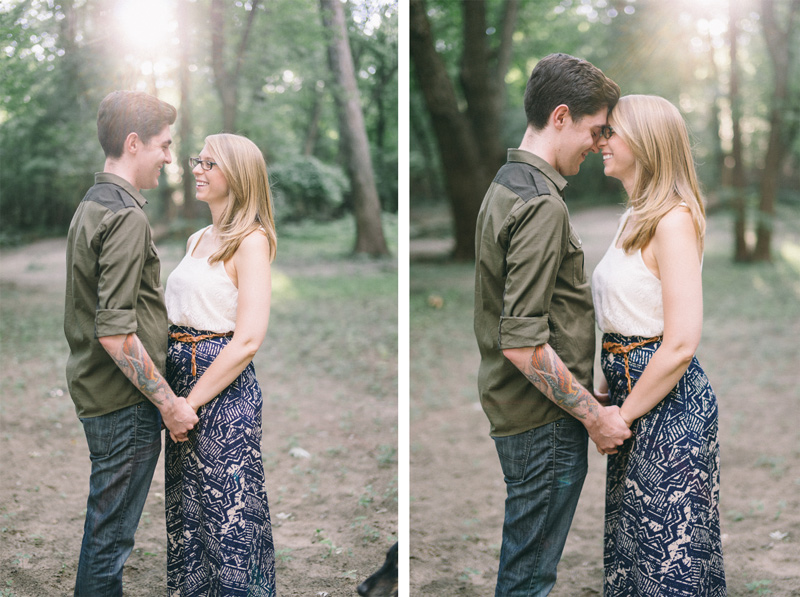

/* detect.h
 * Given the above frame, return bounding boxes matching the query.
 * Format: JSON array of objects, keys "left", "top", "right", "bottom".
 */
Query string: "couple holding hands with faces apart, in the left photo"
[{"left": 64, "top": 91, "right": 276, "bottom": 597}]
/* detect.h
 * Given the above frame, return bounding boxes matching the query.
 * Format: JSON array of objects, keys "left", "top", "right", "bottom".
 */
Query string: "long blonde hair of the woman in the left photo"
[{"left": 206, "top": 133, "right": 278, "bottom": 264}]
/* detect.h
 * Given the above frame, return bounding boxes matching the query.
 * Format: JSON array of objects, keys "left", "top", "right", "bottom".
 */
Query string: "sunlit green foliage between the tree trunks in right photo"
[{"left": 409, "top": 0, "right": 800, "bottom": 256}]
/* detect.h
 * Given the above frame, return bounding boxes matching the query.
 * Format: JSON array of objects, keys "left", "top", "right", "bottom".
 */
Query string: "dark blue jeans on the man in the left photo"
[{"left": 75, "top": 402, "right": 161, "bottom": 597}]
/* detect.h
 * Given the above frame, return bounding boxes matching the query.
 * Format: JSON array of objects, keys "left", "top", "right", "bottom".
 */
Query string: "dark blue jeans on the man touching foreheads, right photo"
[{"left": 494, "top": 419, "right": 588, "bottom": 597}]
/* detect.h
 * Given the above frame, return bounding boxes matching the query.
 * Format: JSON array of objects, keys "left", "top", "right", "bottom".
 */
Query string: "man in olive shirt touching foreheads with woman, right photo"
[{"left": 474, "top": 54, "right": 630, "bottom": 597}]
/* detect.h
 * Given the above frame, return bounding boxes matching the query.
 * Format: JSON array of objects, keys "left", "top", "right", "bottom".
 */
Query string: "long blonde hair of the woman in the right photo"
[{"left": 609, "top": 95, "right": 706, "bottom": 253}]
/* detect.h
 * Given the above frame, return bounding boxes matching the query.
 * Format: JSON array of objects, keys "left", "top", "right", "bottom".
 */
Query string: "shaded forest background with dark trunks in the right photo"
[{"left": 409, "top": 0, "right": 800, "bottom": 261}]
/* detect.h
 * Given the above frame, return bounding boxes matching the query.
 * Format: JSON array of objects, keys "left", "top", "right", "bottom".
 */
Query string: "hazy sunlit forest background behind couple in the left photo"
[{"left": 0, "top": 0, "right": 398, "bottom": 254}]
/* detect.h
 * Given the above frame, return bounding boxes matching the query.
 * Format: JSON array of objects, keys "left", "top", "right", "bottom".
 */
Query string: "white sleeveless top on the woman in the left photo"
[{"left": 164, "top": 226, "right": 239, "bottom": 332}]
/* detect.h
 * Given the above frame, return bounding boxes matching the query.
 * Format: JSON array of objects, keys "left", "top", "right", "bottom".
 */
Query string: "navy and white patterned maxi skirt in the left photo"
[{"left": 165, "top": 326, "right": 275, "bottom": 597}]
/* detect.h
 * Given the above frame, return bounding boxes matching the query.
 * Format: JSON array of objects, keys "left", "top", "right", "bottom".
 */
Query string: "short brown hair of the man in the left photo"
[{"left": 97, "top": 91, "right": 178, "bottom": 158}]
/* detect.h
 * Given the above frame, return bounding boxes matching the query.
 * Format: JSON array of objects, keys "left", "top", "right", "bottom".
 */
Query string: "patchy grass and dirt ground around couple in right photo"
[{"left": 410, "top": 203, "right": 800, "bottom": 597}]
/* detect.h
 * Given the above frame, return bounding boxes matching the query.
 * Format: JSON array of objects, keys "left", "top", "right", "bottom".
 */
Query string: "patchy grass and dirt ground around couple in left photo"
[{"left": 0, "top": 218, "right": 398, "bottom": 597}]
